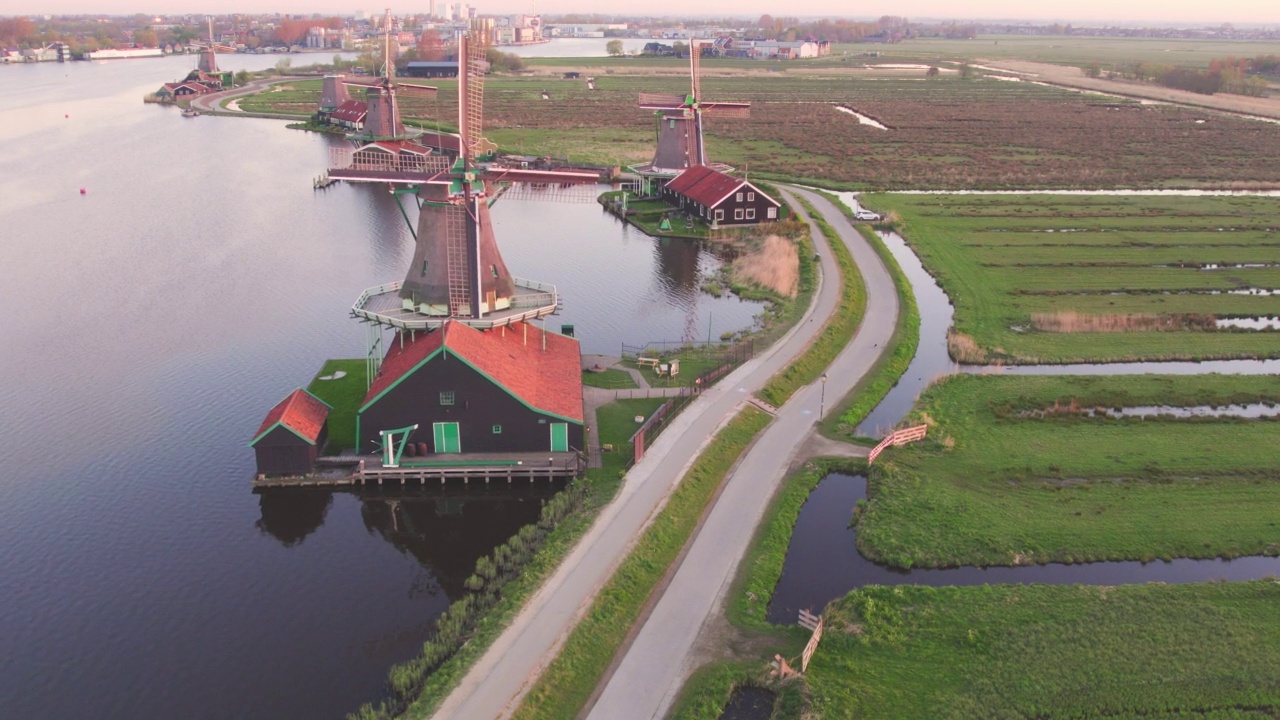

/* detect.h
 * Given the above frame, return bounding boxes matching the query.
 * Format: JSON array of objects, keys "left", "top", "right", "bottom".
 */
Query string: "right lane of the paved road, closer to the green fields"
[{"left": 588, "top": 185, "right": 899, "bottom": 720}]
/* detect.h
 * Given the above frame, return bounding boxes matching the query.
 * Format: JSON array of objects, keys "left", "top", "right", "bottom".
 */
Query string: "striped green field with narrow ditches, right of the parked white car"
[{"left": 865, "top": 195, "right": 1280, "bottom": 363}]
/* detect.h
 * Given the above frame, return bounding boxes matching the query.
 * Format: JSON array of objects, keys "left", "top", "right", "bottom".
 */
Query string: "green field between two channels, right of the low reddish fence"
[{"left": 858, "top": 375, "right": 1280, "bottom": 568}]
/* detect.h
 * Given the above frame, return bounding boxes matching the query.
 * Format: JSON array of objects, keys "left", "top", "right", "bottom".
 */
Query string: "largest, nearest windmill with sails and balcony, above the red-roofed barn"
[{"left": 343, "top": 25, "right": 600, "bottom": 377}]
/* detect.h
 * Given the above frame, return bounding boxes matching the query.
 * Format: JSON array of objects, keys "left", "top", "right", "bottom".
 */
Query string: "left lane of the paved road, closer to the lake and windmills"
[{"left": 435, "top": 185, "right": 849, "bottom": 720}]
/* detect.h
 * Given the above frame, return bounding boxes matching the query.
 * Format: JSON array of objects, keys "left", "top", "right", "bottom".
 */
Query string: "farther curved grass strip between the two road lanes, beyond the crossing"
[{"left": 755, "top": 199, "right": 867, "bottom": 407}]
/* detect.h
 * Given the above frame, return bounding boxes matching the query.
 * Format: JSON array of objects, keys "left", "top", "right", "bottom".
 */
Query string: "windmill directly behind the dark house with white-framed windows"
[{"left": 635, "top": 38, "right": 751, "bottom": 176}]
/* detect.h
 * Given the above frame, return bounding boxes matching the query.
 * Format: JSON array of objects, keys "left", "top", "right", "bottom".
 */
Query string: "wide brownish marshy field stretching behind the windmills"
[{"left": 241, "top": 67, "right": 1280, "bottom": 190}]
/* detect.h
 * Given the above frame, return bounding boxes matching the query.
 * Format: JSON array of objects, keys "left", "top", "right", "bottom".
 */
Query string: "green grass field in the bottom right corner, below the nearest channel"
[{"left": 806, "top": 580, "right": 1280, "bottom": 720}]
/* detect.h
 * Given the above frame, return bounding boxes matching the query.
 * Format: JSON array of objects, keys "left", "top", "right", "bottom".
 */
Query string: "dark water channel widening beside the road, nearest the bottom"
[{"left": 768, "top": 473, "right": 1280, "bottom": 625}]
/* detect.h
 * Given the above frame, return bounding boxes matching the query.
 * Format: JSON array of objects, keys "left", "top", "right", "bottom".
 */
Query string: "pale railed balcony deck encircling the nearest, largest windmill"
[{"left": 351, "top": 278, "right": 559, "bottom": 331}]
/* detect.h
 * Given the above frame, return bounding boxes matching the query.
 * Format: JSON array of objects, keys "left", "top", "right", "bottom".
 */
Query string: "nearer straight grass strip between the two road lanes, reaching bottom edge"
[{"left": 515, "top": 407, "right": 771, "bottom": 720}]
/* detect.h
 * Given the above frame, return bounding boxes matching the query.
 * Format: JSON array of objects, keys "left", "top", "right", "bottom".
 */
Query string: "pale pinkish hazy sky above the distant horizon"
[{"left": 0, "top": 0, "right": 1280, "bottom": 24}]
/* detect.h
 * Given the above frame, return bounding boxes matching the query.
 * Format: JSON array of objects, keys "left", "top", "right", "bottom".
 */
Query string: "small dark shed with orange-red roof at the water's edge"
[{"left": 248, "top": 388, "right": 332, "bottom": 475}]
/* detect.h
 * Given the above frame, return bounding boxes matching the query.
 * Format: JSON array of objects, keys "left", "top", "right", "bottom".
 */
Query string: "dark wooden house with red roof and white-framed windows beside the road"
[{"left": 662, "top": 165, "right": 782, "bottom": 225}]
